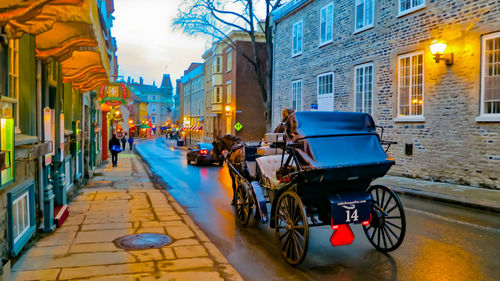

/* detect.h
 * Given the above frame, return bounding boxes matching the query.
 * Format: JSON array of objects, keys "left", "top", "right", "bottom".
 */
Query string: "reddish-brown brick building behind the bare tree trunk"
[{"left": 203, "top": 31, "right": 267, "bottom": 141}]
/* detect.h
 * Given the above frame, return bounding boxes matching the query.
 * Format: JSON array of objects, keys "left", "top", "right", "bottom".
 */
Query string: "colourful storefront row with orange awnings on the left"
[{"left": 0, "top": 0, "right": 116, "bottom": 277}]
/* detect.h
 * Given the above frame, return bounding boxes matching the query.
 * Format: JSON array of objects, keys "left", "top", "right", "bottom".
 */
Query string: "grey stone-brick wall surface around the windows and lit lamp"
[{"left": 273, "top": 0, "right": 500, "bottom": 189}]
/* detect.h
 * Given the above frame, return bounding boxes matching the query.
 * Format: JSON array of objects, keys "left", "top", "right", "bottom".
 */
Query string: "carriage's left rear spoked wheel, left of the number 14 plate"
[{"left": 275, "top": 191, "right": 309, "bottom": 266}]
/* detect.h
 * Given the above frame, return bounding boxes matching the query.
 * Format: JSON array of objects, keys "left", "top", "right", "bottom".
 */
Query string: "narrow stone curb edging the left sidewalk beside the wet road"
[{"left": 134, "top": 144, "right": 243, "bottom": 281}]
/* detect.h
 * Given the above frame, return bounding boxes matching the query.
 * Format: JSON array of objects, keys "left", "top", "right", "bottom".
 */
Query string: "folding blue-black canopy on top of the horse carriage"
[{"left": 287, "top": 111, "right": 394, "bottom": 178}]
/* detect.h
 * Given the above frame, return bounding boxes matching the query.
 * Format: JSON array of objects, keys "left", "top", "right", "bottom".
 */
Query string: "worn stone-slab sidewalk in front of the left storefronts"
[{"left": 11, "top": 153, "right": 242, "bottom": 280}]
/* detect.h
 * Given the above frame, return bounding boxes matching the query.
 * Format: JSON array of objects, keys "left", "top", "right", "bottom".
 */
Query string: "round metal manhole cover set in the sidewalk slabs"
[{"left": 113, "top": 233, "right": 172, "bottom": 250}]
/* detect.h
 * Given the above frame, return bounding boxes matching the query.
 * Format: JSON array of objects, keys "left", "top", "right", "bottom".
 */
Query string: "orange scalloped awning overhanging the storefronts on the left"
[{"left": 0, "top": 0, "right": 112, "bottom": 91}]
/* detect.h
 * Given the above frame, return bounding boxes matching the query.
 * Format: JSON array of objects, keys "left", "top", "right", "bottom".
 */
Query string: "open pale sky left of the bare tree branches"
[{"left": 112, "top": 0, "right": 207, "bottom": 87}]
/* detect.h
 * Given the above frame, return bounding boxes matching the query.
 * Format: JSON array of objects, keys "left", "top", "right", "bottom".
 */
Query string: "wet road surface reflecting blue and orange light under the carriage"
[{"left": 138, "top": 138, "right": 500, "bottom": 281}]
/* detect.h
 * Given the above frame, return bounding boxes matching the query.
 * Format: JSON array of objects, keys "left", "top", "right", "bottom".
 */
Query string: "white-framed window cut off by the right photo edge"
[{"left": 481, "top": 32, "right": 500, "bottom": 115}]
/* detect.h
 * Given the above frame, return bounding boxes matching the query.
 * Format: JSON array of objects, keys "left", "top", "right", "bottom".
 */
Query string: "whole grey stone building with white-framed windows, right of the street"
[{"left": 273, "top": 0, "right": 500, "bottom": 189}]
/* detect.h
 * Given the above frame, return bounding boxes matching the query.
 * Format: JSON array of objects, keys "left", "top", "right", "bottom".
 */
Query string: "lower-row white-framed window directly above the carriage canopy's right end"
[{"left": 354, "top": 63, "right": 373, "bottom": 114}]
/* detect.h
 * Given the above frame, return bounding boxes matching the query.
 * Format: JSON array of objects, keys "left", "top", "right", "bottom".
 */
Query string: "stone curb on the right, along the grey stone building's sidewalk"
[{"left": 391, "top": 186, "right": 500, "bottom": 213}]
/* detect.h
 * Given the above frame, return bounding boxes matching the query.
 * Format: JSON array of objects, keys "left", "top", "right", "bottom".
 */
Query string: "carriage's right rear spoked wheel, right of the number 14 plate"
[{"left": 363, "top": 185, "right": 406, "bottom": 252}]
